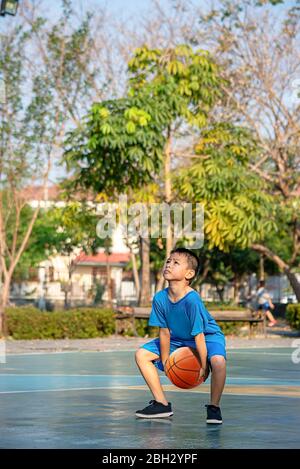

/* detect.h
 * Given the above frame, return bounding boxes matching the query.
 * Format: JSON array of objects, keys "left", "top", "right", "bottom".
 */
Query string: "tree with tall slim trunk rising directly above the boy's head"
[{"left": 129, "top": 44, "right": 221, "bottom": 289}]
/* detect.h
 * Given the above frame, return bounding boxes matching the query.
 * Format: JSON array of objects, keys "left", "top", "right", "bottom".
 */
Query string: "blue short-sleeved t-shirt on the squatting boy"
[{"left": 149, "top": 288, "right": 224, "bottom": 341}]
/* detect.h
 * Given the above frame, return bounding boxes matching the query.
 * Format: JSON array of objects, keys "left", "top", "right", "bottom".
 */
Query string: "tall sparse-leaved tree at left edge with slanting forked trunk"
[{"left": 0, "top": 0, "right": 116, "bottom": 332}]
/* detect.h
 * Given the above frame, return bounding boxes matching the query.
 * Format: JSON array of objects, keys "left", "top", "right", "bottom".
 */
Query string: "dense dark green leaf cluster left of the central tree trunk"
[{"left": 65, "top": 97, "right": 164, "bottom": 195}]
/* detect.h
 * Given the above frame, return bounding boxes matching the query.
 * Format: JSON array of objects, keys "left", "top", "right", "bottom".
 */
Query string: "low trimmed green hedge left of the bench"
[{"left": 6, "top": 306, "right": 115, "bottom": 339}]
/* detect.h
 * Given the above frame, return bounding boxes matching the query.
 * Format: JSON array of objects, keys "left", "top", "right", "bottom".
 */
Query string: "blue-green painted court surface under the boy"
[{"left": 0, "top": 348, "right": 300, "bottom": 449}]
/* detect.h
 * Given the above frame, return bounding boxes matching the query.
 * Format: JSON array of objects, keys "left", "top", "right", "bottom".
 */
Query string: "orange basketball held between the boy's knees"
[{"left": 165, "top": 347, "right": 204, "bottom": 389}]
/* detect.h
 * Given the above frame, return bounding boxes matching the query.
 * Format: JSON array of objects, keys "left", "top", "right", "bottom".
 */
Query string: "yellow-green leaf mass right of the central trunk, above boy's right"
[{"left": 176, "top": 123, "right": 276, "bottom": 252}]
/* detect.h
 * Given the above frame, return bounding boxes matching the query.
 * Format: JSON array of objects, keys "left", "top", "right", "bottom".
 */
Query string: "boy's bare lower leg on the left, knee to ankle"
[{"left": 135, "top": 348, "right": 168, "bottom": 405}]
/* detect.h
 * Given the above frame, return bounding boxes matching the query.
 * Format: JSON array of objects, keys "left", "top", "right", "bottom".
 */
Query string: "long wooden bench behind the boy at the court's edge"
[{"left": 115, "top": 306, "right": 266, "bottom": 339}]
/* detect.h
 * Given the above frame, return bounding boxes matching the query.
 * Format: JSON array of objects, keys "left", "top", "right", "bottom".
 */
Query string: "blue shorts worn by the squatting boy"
[{"left": 140, "top": 335, "right": 226, "bottom": 371}]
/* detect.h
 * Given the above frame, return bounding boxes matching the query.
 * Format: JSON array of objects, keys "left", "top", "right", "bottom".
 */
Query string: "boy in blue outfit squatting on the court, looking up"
[{"left": 135, "top": 248, "right": 226, "bottom": 424}]
